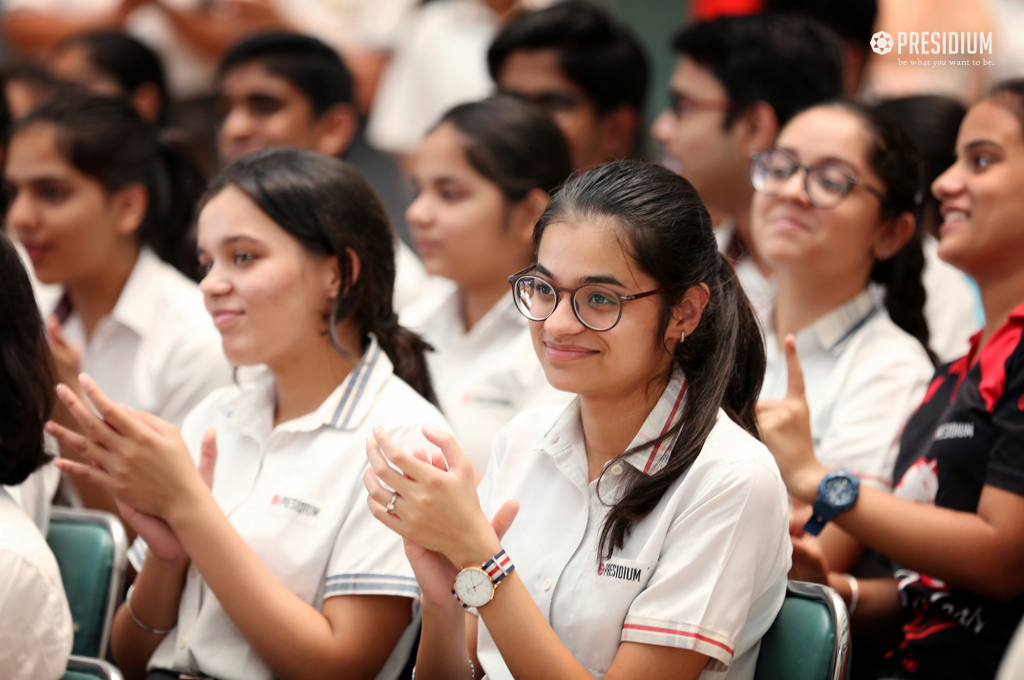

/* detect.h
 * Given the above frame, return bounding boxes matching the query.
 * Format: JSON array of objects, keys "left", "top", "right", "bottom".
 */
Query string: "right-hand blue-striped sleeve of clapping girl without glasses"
[{"left": 324, "top": 424, "right": 428, "bottom": 599}]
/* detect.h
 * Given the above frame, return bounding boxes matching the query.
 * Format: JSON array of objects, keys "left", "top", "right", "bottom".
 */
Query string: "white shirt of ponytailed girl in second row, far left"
[{"left": 53, "top": 248, "right": 231, "bottom": 427}]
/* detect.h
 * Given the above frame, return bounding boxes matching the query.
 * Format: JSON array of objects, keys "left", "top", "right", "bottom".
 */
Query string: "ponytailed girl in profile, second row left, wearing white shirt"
[{"left": 5, "top": 94, "right": 231, "bottom": 524}]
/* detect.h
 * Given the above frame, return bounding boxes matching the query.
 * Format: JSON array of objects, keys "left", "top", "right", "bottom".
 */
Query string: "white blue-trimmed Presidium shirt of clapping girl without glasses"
[{"left": 128, "top": 338, "right": 449, "bottom": 680}]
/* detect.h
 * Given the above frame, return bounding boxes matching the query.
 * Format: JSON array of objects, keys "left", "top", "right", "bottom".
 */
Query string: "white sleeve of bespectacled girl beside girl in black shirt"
[{"left": 811, "top": 351, "right": 934, "bottom": 491}]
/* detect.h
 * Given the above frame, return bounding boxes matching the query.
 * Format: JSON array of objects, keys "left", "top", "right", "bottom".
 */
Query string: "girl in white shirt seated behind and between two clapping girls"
[{"left": 402, "top": 96, "right": 572, "bottom": 475}]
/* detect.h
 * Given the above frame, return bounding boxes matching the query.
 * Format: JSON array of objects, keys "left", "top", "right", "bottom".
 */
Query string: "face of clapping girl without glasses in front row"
[{"left": 198, "top": 186, "right": 338, "bottom": 371}]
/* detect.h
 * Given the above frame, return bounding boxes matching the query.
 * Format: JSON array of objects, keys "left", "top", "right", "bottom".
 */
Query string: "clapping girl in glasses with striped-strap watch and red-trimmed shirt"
[{"left": 366, "top": 162, "right": 791, "bottom": 680}]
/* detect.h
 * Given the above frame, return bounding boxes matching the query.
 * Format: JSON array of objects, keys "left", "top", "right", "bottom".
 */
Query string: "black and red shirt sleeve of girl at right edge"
[{"left": 981, "top": 326, "right": 1024, "bottom": 496}]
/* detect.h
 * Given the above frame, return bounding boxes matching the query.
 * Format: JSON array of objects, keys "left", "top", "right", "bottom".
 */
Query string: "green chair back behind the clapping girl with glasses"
[{"left": 754, "top": 581, "right": 850, "bottom": 680}]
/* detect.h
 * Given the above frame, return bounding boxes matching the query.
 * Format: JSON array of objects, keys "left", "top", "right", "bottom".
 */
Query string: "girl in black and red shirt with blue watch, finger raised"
[{"left": 759, "top": 80, "right": 1024, "bottom": 679}]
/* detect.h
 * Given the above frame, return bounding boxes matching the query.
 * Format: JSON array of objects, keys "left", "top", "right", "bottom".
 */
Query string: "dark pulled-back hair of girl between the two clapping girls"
[{"left": 437, "top": 95, "right": 572, "bottom": 203}]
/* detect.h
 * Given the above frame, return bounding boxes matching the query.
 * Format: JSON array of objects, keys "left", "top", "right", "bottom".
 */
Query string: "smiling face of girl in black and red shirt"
[{"left": 932, "top": 95, "right": 1024, "bottom": 281}]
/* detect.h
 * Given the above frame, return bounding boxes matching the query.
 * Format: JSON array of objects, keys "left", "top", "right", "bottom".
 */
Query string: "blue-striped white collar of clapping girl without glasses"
[{"left": 225, "top": 334, "right": 394, "bottom": 439}]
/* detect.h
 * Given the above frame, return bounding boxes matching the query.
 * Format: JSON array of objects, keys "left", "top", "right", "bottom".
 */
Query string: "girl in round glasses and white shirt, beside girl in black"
[{"left": 751, "top": 103, "right": 934, "bottom": 578}]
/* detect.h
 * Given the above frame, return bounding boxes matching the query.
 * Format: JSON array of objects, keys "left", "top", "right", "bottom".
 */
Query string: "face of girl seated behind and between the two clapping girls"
[{"left": 406, "top": 123, "right": 544, "bottom": 288}]
